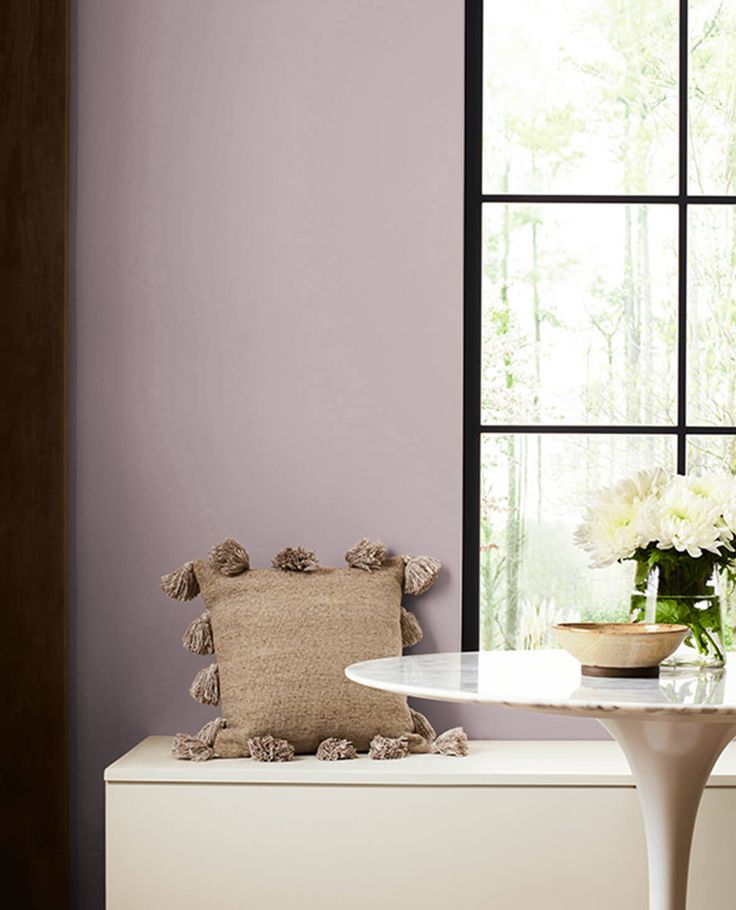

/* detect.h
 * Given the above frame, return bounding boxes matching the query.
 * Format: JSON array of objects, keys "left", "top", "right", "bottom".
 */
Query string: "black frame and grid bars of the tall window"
[{"left": 461, "top": 0, "right": 736, "bottom": 651}]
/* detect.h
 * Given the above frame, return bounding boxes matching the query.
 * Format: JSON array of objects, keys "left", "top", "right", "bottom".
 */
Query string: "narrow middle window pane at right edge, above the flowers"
[{"left": 687, "top": 205, "right": 736, "bottom": 426}]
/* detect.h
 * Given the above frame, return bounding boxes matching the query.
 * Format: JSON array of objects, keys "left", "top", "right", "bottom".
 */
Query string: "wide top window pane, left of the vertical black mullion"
[{"left": 483, "top": 0, "right": 678, "bottom": 193}]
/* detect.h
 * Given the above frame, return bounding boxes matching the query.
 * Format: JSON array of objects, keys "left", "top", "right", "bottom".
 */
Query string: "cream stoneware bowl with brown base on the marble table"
[{"left": 552, "top": 622, "right": 689, "bottom": 678}]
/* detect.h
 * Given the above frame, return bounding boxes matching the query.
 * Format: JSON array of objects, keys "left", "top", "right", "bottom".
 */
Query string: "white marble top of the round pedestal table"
[{"left": 345, "top": 650, "right": 736, "bottom": 720}]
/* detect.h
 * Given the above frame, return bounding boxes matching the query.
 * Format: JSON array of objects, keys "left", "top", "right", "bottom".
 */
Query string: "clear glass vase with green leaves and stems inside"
[{"left": 630, "top": 560, "right": 726, "bottom": 669}]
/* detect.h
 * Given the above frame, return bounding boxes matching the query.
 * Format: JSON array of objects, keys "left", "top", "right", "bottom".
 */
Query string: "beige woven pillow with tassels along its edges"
[{"left": 162, "top": 539, "right": 465, "bottom": 761}]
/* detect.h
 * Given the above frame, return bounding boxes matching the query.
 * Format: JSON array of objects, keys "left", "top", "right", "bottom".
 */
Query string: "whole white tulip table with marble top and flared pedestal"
[{"left": 345, "top": 650, "right": 736, "bottom": 910}]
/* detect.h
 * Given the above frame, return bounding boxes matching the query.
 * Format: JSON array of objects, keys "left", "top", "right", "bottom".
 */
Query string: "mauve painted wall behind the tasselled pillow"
[{"left": 71, "top": 0, "right": 596, "bottom": 910}]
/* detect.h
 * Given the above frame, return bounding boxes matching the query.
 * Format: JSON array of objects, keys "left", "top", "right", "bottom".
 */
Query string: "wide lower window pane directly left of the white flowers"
[{"left": 480, "top": 434, "right": 676, "bottom": 650}]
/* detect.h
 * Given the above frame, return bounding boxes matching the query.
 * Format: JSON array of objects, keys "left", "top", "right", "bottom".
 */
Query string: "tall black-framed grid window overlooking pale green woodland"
[{"left": 464, "top": 0, "right": 736, "bottom": 649}]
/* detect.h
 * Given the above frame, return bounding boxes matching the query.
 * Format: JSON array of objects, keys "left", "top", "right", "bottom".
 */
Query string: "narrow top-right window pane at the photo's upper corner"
[{"left": 688, "top": 0, "right": 736, "bottom": 195}]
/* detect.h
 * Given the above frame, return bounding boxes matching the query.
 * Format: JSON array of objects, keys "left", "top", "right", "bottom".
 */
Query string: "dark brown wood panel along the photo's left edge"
[{"left": 0, "top": 0, "right": 69, "bottom": 910}]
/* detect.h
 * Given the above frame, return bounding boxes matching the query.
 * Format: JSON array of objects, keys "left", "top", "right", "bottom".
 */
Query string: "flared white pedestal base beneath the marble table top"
[{"left": 601, "top": 714, "right": 736, "bottom": 910}]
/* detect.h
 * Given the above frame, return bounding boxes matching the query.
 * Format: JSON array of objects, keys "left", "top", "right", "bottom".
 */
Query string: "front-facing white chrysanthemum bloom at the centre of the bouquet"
[{"left": 657, "top": 477, "right": 724, "bottom": 559}]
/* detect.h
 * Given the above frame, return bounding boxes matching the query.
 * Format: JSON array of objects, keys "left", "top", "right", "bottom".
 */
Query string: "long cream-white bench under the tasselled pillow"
[{"left": 105, "top": 736, "right": 736, "bottom": 910}]
